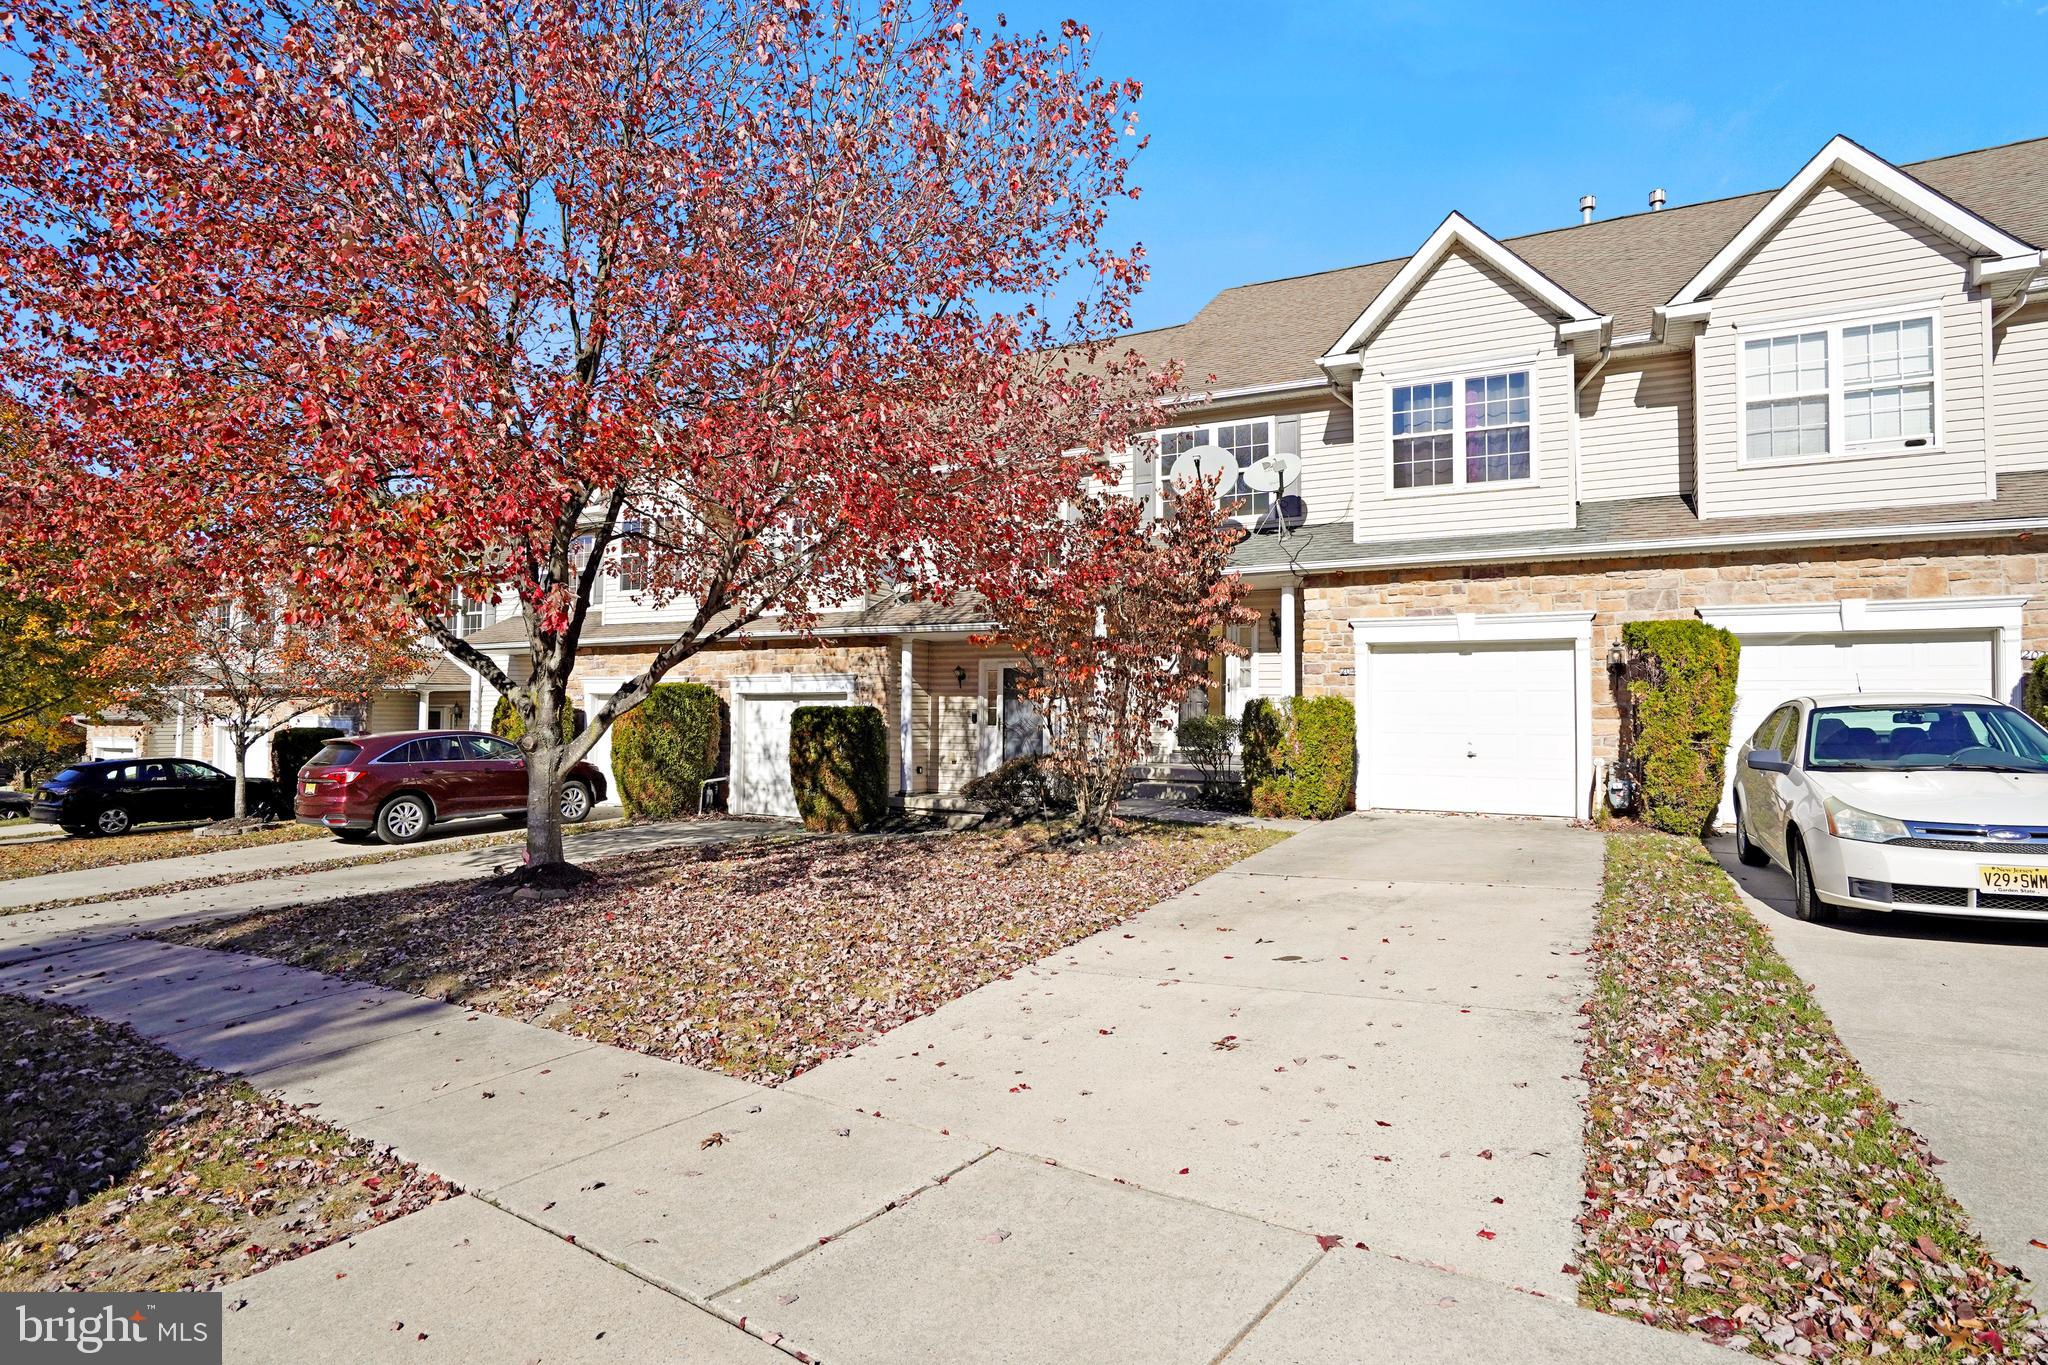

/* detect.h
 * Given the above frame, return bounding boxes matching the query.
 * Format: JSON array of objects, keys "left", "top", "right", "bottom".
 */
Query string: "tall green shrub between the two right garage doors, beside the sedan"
[{"left": 1622, "top": 620, "right": 1743, "bottom": 835}]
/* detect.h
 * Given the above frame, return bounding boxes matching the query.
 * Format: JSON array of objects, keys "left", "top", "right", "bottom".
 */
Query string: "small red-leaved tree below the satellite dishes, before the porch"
[{"left": 983, "top": 480, "right": 1257, "bottom": 839}]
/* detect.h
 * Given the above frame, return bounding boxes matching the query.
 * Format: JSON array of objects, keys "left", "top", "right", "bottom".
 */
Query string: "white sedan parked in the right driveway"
[{"left": 1735, "top": 692, "right": 2048, "bottom": 921}]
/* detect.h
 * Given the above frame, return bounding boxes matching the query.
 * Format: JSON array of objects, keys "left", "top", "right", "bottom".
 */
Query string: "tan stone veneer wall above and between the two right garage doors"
[{"left": 1300, "top": 536, "right": 2048, "bottom": 759}]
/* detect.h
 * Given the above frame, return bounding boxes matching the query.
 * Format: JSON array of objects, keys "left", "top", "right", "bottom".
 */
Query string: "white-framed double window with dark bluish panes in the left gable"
[{"left": 1391, "top": 370, "right": 1534, "bottom": 489}]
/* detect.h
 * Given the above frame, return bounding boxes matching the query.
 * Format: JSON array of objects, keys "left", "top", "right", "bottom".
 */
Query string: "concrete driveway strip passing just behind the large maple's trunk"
[{"left": 0, "top": 821, "right": 782, "bottom": 962}]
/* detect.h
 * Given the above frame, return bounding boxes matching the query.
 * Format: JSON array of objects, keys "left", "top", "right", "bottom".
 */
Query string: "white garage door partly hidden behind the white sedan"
[{"left": 1720, "top": 634, "right": 1993, "bottom": 823}]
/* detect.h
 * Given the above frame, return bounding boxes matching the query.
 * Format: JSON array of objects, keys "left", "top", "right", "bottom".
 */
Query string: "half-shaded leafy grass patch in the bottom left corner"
[{"left": 0, "top": 995, "right": 455, "bottom": 1293}]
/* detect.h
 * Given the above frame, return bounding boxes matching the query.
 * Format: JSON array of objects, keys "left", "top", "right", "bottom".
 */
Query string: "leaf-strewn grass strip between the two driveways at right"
[{"left": 1579, "top": 835, "right": 2048, "bottom": 1361}]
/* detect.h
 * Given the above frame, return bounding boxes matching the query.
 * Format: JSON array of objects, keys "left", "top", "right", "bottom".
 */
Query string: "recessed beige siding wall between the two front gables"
[{"left": 1579, "top": 352, "right": 1692, "bottom": 501}]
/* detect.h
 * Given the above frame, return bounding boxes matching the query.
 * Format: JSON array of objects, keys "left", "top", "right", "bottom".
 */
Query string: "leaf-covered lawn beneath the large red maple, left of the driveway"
[{"left": 164, "top": 825, "right": 1284, "bottom": 1085}]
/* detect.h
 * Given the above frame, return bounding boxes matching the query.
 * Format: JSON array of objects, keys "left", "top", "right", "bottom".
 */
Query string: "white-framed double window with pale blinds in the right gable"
[{"left": 1743, "top": 315, "right": 1935, "bottom": 463}]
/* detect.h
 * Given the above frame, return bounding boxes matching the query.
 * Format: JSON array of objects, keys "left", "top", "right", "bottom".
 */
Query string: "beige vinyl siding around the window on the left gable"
[{"left": 1352, "top": 250, "right": 1575, "bottom": 542}]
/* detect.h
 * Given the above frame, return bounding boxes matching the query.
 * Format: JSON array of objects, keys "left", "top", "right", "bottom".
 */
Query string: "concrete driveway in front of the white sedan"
[{"left": 1708, "top": 837, "right": 2048, "bottom": 1285}]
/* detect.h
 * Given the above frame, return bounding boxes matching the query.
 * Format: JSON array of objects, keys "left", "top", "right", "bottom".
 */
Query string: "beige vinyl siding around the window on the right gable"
[{"left": 1694, "top": 180, "right": 1993, "bottom": 518}]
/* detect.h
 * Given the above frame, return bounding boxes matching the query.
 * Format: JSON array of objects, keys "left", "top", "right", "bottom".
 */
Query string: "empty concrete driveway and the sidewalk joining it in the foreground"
[{"left": 0, "top": 821, "right": 1720, "bottom": 1365}]
